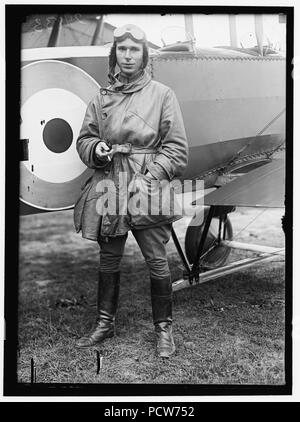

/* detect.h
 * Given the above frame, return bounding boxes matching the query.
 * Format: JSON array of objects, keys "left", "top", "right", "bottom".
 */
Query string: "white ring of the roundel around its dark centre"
[{"left": 21, "top": 88, "right": 86, "bottom": 183}]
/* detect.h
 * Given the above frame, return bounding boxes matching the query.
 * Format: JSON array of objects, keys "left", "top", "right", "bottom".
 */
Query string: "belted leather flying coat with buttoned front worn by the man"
[{"left": 74, "top": 71, "right": 188, "bottom": 240}]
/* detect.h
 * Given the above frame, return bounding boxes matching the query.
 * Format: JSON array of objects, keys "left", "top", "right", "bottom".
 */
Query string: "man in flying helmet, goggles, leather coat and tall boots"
[{"left": 74, "top": 24, "right": 188, "bottom": 357}]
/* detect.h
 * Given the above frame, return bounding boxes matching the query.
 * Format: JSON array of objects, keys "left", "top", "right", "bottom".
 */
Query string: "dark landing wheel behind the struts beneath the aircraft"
[{"left": 185, "top": 210, "right": 233, "bottom": 269}]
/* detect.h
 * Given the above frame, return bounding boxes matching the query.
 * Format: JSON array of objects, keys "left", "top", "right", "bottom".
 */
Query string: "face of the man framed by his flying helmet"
[{"left": 116, "top": 38, "right": 143, "bottom": 77}]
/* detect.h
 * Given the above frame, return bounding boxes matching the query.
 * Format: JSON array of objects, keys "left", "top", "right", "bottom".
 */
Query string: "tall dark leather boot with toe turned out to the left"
[{"left": 75, "top": 271, "right": 120, "bottom": 347}]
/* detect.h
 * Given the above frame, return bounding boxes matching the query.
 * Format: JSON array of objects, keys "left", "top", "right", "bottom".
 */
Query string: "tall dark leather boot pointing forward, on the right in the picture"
[{"left": 151, "top": 277, "right": 175, "bottom": 358}]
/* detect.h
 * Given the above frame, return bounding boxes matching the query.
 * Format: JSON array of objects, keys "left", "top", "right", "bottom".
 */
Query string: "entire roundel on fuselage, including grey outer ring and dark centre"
[{"left": 19, "top": 60, "right": 100, "bottom": 213}]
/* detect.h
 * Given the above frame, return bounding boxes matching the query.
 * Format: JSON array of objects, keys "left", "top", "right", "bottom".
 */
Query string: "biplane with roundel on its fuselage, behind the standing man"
[{"left": 20, "top": 15, "right": 286, "bottom": 290}]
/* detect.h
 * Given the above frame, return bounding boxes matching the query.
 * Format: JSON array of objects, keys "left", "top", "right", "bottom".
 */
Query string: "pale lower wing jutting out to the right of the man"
[{"left": 204, "top": 159, "right": 285, "bottom": 208}]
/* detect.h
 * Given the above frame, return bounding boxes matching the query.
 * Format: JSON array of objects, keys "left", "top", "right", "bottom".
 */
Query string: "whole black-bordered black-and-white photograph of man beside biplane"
[{"left": 4, "top": 4, "right": 294, "bottom": 396}]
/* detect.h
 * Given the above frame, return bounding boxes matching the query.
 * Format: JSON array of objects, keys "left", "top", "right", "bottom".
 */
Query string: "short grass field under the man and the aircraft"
[{"left": 18, "top": 209, "right": 285, "bottom": 385}]
